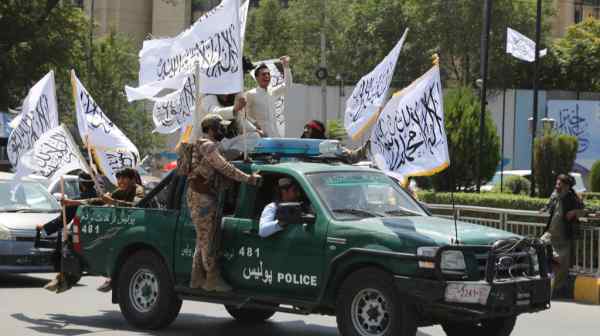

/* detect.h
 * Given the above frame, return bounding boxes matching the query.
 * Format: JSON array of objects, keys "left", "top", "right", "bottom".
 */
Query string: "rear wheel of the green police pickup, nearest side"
[{"left": 116, "top": 250, "right": 181, "bottom": 330}]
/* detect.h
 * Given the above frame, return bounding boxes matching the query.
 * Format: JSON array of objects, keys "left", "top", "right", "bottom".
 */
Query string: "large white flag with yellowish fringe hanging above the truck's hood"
[{"left": 371, "top": 65, "right": 450, "bottom": 179}]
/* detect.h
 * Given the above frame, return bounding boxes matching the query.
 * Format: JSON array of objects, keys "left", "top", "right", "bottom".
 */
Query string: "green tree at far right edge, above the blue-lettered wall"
[{"left": 552, "top": 18, "right": 600, "bottom": 92}]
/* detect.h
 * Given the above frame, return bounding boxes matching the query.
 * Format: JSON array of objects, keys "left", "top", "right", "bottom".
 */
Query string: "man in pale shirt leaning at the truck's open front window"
[{"left": 258, "top": 177, "right": 302, "bottom": 238}]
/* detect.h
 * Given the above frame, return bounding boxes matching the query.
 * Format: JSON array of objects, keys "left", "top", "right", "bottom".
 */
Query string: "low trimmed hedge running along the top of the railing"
[{"left": 417, "top": 191, "right": 600, "bottom": 210}]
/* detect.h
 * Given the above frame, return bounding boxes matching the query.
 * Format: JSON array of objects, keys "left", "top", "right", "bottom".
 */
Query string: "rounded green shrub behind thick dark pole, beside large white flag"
[{"left": 433, "top": 86, "right": 500, "bottom": 191}]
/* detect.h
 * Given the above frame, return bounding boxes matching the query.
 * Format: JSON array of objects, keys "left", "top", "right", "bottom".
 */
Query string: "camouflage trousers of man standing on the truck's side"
[{"left": 187, "top": 188, "right": 218, "bottom": 287}]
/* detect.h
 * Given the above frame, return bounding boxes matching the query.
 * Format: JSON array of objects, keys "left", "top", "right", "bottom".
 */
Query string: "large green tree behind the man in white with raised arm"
[{"left": 245, "top": 0, "right": 422, "bottom": 87}]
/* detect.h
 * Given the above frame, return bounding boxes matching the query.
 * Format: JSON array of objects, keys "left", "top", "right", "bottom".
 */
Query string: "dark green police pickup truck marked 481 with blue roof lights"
[{"left": 72, "top": 139, "right": 550, "bottom": 336}]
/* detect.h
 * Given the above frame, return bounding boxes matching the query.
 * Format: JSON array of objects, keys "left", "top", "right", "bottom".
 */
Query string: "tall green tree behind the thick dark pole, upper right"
[{"left": 406, "top": 0, "right": 553, "bottom": 88}]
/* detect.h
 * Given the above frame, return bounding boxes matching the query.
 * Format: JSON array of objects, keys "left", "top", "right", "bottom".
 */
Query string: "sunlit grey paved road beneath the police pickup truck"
[{"left": 0, "top": 274, "right": 600, "bottom": 336}]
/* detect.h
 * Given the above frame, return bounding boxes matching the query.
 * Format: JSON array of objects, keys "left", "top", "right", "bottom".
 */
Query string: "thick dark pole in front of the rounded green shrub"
[{"left": 477, "top": 0, "right": 492, "bottom": 192}]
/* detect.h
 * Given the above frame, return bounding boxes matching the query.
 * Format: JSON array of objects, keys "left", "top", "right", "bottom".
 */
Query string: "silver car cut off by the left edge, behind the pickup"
[{"left": 0, "top": 173, "right": 60, "bottom": 273}]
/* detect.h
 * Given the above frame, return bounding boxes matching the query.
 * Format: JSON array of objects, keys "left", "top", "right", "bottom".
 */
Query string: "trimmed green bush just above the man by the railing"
[{"left": 533, "top": 132, "right": 578, "bottom": 197}]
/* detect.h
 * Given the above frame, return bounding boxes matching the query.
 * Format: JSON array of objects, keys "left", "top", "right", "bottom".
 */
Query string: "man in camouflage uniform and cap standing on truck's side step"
[{"left": 187, "top": 115, "right": 260, "bottom": 292}]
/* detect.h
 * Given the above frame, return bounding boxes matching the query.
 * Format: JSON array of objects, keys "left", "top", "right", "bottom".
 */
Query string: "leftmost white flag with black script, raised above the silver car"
[{"left": 6, "top": 71, "right": 58, "bottom": 168}]
